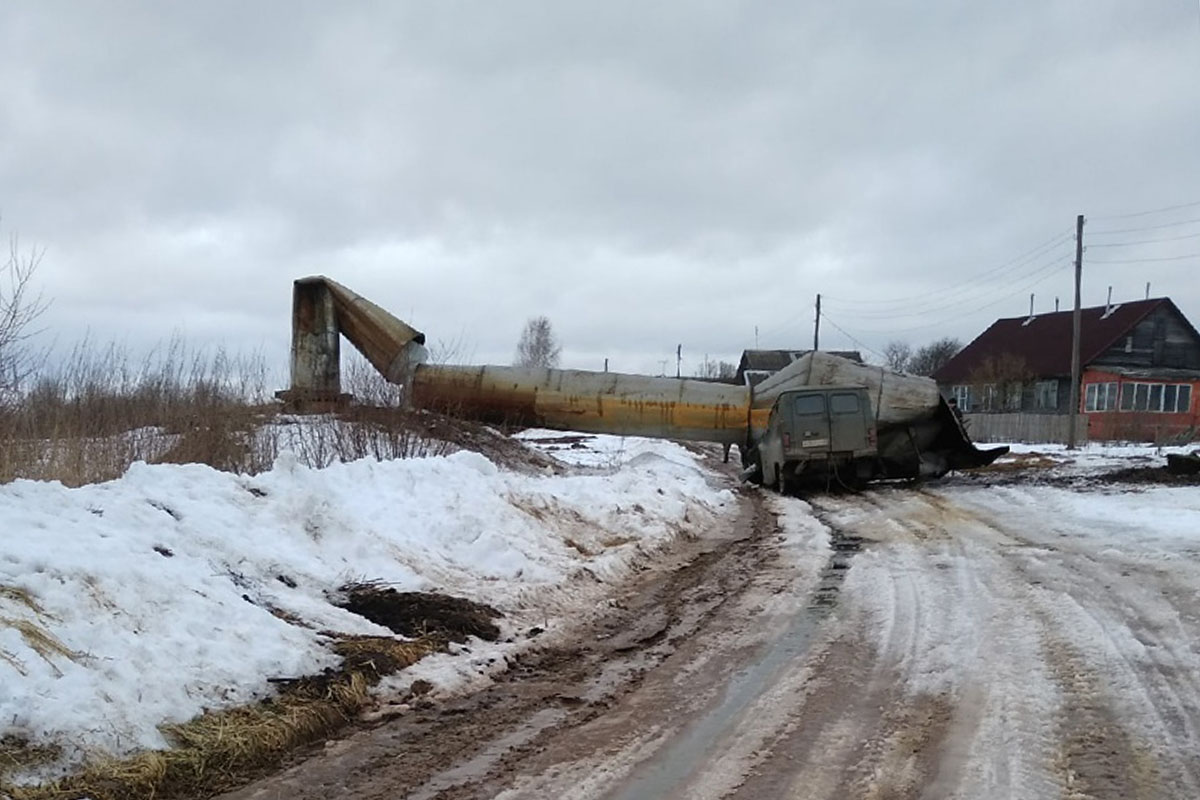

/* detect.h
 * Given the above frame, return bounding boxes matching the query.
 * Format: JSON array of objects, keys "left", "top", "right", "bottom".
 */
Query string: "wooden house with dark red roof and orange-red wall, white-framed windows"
[{"left": 934, "top": 297, "right": 1200, "bottom": 441}]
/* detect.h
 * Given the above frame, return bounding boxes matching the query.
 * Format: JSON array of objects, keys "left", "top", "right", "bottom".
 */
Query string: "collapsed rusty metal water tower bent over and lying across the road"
[{"left": 280, "top": 276, "right": 1007, "bottom": 477}]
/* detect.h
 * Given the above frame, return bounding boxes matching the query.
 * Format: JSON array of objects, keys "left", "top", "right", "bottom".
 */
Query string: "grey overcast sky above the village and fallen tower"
[{"left": 0, "top": 0, "right": 1200, "bottom": 373}]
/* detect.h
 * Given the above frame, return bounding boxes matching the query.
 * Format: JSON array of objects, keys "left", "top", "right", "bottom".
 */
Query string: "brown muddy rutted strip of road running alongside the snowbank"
[{"left": 223, "top": 491, "right": 796, "bottom": 800}]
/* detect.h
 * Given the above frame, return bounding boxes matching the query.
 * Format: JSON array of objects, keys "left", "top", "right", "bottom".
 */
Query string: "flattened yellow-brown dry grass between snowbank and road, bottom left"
[{"left": 0, "top": 637, "right": 439, "bottom": 800}]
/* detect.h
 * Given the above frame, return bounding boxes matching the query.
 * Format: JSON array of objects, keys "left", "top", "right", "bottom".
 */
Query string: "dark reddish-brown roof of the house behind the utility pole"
[{"left": 934, "top": 297, "right": 1190, "bottom": 384}]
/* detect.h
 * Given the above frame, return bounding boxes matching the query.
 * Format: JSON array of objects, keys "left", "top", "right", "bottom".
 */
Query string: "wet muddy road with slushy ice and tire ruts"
[{"left": 220, "top": 474, "right": 1200, "bottom": 800}]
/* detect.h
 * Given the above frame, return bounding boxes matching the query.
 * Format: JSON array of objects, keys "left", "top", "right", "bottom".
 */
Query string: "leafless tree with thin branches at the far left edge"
[{"left": 0, "top": 231, "right": 50, "bottom": 391}]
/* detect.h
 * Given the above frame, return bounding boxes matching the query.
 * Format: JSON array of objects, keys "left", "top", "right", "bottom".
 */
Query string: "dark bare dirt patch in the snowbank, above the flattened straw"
[{"left": 337, "top": 583, "right": 503, "bottom": 642}]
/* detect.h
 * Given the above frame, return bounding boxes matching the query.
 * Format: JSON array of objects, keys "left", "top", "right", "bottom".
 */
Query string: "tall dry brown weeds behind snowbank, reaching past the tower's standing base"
[{"left": 0, "top": 339, "right": 463, "bottom": 486}]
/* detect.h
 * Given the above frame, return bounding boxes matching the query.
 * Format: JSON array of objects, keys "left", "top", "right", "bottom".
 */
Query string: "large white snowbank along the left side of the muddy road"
[{"left": 0, "top": 432, "right": 733, "bottom": 777}]
